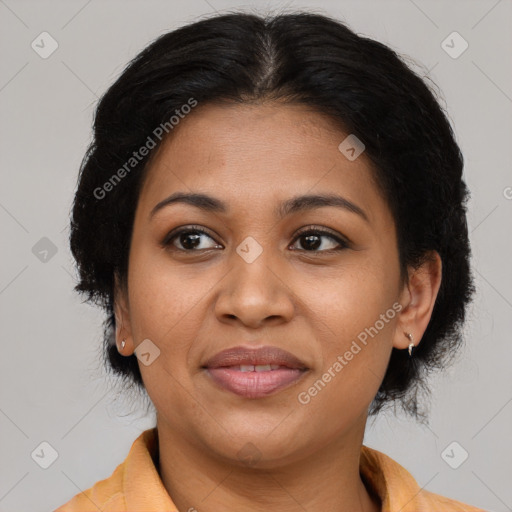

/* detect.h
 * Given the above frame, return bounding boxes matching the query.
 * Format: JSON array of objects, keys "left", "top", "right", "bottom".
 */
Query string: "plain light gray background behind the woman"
[{"left": 0, "top": 0, "right": 512, "bottom": 512}]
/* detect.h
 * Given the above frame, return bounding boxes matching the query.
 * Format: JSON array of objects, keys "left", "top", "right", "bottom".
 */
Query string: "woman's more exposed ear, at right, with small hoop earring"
[{"left": 393, "top": 251, "right": 442, "bottom": 349}]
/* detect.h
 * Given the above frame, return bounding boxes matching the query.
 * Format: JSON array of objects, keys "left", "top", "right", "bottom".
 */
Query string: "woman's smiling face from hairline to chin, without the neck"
[{"left": 116, "top": 103, "right": 424, "bottom": 466}]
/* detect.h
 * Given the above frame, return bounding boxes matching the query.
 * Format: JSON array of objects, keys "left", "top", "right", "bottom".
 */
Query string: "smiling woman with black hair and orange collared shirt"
[{"left": 58, "top": 9, "right": 484, "bottom": 512}]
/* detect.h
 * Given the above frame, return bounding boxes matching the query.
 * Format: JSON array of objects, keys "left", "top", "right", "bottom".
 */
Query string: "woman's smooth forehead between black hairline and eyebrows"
[{"left": 136, "top": 102, "right": 386, "bottom": 225}]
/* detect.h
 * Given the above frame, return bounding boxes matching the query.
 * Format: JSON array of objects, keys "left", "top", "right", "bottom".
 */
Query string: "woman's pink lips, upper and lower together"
[{"left": 203, "top": 346, "right": 308, "bottom": 398}]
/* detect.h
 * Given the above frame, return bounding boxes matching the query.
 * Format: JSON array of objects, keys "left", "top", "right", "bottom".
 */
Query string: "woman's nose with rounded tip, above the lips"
[{"left": 215, "top": 251, "right": 295, "bottom": 329}]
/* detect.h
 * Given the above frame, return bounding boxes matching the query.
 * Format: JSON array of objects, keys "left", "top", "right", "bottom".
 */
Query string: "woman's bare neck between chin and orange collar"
[{"left": 157, "top": 417, "right": 381, "bottom": 512}]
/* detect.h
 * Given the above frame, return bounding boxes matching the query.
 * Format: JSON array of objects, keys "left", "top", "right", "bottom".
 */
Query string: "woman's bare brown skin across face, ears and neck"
[{"left": 115, "top": 102, "right": 441, "bottom": 512}]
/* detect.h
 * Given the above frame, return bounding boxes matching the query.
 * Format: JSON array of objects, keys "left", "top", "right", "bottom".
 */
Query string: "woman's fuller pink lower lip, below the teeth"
[{"left": 207, "top": 367, "right": 306, "bottom": 398}]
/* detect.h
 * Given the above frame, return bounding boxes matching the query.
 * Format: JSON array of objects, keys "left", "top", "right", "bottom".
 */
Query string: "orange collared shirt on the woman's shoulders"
[{"left": 54, "top": 427, "right": 485, "bottom": 512}]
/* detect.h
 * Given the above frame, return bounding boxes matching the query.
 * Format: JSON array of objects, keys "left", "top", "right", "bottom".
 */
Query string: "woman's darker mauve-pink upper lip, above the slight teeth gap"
[{"left": 203, "top": 345, "right": 307, "bottom": 370}]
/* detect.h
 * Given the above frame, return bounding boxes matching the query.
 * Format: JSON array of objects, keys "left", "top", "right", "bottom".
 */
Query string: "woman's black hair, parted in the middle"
[{"left": 70, "top": 12, "right": 475, "bottom": 419}]
